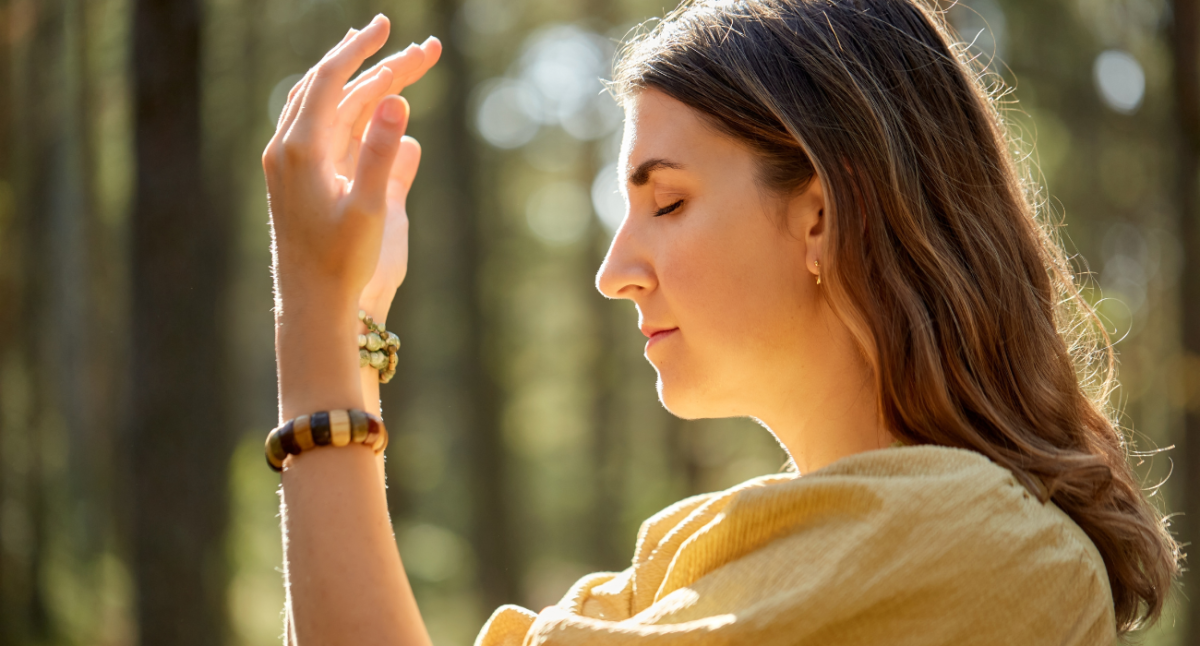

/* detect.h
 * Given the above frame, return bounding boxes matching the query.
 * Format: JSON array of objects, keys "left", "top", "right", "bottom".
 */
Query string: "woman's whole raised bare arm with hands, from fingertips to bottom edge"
[{"left": 263, "top": 17, "right": 439, "bottom": 646}]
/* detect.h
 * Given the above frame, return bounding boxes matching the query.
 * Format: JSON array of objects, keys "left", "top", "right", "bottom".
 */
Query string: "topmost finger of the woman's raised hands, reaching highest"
[{"left": 298, "top": 14, "right": 390, "bottom": 139}]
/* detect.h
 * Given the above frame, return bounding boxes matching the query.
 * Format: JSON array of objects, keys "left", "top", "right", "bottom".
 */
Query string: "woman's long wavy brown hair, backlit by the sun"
[{"left": 613, "top": 0, "right": 1180, "bottom": 633}]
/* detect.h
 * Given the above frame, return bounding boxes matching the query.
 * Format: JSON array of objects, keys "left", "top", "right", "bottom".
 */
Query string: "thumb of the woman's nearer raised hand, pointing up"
[{"left": 350, "top": 95, "right": 408, "bottom": 214}]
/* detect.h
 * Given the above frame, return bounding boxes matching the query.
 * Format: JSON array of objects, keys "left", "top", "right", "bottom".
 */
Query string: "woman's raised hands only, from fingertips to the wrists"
[{"left": 263, "top": 16, "right": 442, "bottom": 316}]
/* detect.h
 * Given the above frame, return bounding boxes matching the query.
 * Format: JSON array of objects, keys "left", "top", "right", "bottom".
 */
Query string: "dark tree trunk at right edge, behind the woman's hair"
[{"left": 1171, "top": 0, "right": 1200, "bottom": 644}]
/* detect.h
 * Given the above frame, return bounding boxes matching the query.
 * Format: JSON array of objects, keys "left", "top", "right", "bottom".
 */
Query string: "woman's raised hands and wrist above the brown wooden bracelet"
[{"left": 263, "top": 16, "right": 440, "bottom": 414}]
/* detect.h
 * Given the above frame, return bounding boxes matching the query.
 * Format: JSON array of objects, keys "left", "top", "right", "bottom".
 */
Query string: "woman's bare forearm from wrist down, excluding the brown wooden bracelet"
[{"left": 276, "top": 292, "right": 428, "bottom": 646}]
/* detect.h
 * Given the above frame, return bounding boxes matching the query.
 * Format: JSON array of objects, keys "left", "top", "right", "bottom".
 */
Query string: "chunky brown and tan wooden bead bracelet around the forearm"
[{"left": 266, "top": 408, "right": 388, "bottom": 472}]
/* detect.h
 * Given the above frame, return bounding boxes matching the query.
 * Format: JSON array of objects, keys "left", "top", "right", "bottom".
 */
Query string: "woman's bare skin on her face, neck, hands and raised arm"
[{"left": 263, "top": 16, "right": 892, "bottom": 646}]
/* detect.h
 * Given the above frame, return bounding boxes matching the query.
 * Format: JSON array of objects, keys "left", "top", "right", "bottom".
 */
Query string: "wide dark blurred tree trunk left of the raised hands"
[{"left": 130, "top": 0, "right": 232, "bottom": 646}]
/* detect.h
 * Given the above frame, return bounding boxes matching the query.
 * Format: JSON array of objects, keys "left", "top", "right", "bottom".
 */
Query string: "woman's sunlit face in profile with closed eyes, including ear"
[{"left": 596, "top": 90, "right": 828, "bottom": 419}]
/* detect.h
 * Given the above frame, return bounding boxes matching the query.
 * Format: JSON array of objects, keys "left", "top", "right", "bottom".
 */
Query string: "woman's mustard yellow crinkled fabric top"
[{"left": 475, "top": 447, "right": 1116, "bottom": 646}]
